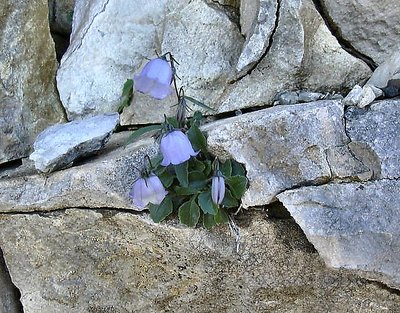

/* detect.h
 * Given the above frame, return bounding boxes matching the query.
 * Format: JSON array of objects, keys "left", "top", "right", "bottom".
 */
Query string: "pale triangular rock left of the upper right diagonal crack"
[{"left": 218, "top": 0, "right": 371, "bottom": 112}]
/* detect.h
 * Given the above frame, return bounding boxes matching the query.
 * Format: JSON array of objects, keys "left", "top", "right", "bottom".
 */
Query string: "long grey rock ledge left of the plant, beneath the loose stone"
[{"left": 0, "top": 134, "right": 156, "bottom": 212}]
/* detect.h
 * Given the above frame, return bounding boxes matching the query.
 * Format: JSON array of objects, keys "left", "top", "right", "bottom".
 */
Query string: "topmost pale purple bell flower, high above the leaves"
[{"left": 133, "top": 58, "right": 173, "bottom": 100}]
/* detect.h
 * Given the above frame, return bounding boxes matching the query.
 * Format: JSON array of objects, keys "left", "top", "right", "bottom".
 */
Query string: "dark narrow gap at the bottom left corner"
[{"left": 0, "top": 249, "right": 24, "bottom": 313}]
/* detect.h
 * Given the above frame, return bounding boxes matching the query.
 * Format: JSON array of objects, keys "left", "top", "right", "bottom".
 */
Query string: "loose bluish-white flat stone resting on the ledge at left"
[{"left": 29, "top": 113, "right": 119, "bottom": 173}]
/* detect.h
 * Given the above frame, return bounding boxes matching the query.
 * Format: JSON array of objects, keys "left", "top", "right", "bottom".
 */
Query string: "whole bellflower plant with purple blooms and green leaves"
[{"left": 118, "top": 53, "right": 248, "bottom": 229}]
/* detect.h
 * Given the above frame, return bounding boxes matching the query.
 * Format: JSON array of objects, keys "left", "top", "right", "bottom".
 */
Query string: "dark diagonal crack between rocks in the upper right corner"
[{"left": 312, "top": 0, "right": 378, "bottom": 71}]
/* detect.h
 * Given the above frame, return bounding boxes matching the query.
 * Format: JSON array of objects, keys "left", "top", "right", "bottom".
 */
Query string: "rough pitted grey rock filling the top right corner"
[{"left": 318, "top": 0, "right": 400, "bottom": 65}]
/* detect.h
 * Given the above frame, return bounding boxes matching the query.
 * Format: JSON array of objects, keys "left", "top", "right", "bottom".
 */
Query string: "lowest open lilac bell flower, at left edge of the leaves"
[{"left": 129, "top": 174, "right": 168, "bottom": 209}]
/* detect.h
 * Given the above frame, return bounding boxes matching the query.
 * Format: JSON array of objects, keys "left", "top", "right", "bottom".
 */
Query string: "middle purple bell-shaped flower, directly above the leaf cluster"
[{"left": 160, "top": 130, "right": 199, "bottom": 166}]
